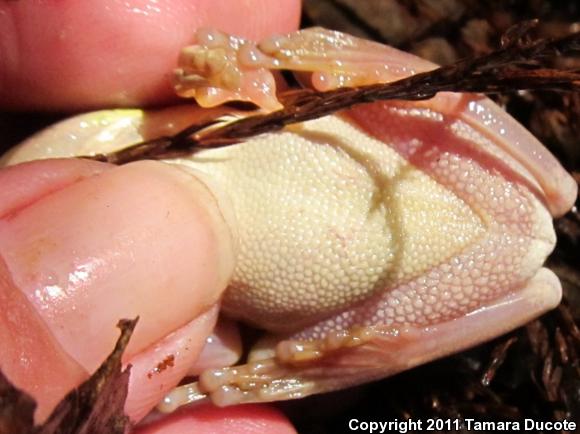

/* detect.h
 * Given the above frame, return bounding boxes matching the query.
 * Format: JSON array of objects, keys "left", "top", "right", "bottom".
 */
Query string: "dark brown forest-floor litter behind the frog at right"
[{"left": 283, "top": 0, "right": 580, "bottom": 434}]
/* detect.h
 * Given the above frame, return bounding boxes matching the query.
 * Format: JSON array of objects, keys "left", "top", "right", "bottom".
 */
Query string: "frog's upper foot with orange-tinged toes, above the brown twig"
[{"left": 174, "top": 27, "right": 435, "bottom": 111}]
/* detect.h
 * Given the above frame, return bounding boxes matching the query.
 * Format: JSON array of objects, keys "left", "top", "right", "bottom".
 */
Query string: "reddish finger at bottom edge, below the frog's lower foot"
[{"left": 134, "top": 404, "right": 296, "bottom": 434}]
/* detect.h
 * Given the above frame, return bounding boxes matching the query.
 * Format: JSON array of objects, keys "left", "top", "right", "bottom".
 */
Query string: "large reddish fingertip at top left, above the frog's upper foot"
[{"left": 0, "top": 0, "right": 300, "bottom": 110}]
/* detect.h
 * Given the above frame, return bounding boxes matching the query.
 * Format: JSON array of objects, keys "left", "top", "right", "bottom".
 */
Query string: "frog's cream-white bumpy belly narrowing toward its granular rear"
[{"left": 176, "top": 107, "right": 555, "bottom": 338}]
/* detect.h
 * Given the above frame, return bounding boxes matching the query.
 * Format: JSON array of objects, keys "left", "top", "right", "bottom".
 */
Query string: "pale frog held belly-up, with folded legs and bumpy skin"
[{"left": 4, "top": 28, "right": 577, "bottom": 412}]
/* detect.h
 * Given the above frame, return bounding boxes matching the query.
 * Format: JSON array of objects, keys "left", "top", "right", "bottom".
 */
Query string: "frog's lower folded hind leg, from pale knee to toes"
[{"left": 159, "top": 268, "right": 561, "bottom": 412}]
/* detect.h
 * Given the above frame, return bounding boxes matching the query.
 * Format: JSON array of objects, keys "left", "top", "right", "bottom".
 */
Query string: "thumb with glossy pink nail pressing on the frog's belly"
[{"left": 0, "top": 160, "right": 235, "bottom": 415}]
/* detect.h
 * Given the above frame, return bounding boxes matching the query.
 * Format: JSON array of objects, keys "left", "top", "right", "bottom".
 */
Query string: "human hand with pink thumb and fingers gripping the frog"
[{"left": 0, "top": 0, "right": 299, "bottom": 432}]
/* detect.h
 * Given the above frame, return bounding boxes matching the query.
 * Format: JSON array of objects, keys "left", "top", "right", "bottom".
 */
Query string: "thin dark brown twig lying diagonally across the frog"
[{"left": 88, "top": 22, "right": 580, "bottom": 164}]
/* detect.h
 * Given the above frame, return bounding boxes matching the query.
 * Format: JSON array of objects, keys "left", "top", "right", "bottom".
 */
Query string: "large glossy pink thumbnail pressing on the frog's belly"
[{"left": 0, "top": 162, "right": 235, "bottom": 372}]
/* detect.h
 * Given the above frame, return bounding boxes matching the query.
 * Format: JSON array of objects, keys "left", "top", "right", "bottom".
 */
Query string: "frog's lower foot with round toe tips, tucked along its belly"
[{"left": 158, "top": 327, "right": 398, "bottom": 412}]
